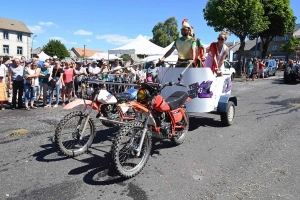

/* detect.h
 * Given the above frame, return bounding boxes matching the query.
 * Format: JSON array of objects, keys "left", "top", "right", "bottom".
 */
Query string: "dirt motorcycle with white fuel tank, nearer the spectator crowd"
[{"left": 54, "top": 77, "right": 138, "bottom": 157}]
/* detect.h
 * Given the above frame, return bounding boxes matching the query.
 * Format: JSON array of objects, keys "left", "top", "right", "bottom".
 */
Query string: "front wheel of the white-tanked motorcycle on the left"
[{"left": 54, "top": 111, "right": 95, "bottom": 157}]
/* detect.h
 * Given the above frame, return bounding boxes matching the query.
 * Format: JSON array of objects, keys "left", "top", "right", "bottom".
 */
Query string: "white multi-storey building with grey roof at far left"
[{"left": 0, "top": 17, "right": 32, "bottom": 59}]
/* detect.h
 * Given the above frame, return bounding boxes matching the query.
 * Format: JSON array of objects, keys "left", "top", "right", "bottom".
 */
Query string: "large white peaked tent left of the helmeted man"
[{"left": 108, "top": 35, "right": 166, "bottom": 55}]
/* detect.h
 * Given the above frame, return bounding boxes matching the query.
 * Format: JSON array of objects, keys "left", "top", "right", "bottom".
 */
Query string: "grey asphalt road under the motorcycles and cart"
[{"left": 0, "top": 72, "right": 300, "bottom": 200}]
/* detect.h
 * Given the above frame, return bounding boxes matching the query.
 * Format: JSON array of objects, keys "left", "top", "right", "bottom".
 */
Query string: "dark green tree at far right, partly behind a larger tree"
[{"left": 259, "top": 0, "right": 296, "bottom": 58}]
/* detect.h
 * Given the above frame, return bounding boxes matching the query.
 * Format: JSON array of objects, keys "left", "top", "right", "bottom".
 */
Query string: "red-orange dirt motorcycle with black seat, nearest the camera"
[{"left": 112, "top": 79, "right": 191, "bottom": 178}]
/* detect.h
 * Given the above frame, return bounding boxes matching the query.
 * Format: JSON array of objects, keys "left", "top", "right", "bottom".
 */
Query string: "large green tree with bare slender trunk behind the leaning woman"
[{"left": 203, "top": 0, "right": 269, "bottom": 75}]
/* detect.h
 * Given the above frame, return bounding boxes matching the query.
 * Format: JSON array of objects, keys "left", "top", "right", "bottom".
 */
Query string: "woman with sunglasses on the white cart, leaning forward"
[{"left": 204, "top": 30, "right": 229, "bottom": 76}]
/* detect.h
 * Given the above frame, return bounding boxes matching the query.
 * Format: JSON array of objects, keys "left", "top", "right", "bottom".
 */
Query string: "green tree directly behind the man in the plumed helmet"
[{"left": 150, "top": 17, "right": 179, "bottom": 47}]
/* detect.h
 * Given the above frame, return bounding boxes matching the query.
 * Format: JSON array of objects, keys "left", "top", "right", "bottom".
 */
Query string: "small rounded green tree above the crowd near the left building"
[{"left": 43, "top": 39, "right": 70, "bottom": 59}]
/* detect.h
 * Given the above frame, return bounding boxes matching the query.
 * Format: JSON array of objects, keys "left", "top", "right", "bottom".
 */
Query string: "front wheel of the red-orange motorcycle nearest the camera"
[{"left": 112, "top": 121, "right": 152, "bottom": 178}]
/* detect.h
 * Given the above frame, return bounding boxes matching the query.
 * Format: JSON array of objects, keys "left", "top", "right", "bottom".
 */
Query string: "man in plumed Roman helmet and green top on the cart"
[{"left": 160, "top": 19, "right": 196, "bottom": 67}]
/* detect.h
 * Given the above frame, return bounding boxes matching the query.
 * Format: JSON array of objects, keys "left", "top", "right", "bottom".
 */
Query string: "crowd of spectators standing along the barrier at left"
[{"left": 0, "top": 56, "right": 158, "bottom": 110}]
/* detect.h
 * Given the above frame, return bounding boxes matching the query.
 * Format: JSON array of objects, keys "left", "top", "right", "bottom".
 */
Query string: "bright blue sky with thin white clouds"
[{"left": 1, "top": 0, "right": 300, "bottom": 52}]
